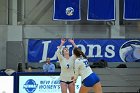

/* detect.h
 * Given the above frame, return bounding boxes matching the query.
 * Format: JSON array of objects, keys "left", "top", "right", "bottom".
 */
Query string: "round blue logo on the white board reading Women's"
[{"left": 23, "top": 79, "right": 38, "bottom": 93}]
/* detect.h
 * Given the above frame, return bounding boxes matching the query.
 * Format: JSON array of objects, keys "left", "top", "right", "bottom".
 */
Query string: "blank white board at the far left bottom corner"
[{"left": 0, "top": 76, "right": 14, "bottom": 93}]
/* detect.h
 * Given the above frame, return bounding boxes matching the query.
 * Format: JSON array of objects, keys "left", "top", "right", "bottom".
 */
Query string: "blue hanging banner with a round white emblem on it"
[{"left": 53, "top": 0, "right": 81, "bottom": 21}]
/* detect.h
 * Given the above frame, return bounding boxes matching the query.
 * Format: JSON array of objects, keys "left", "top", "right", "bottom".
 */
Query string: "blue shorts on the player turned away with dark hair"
[{"left": 82, "top": 73, "right": 100, "bottom": 87}]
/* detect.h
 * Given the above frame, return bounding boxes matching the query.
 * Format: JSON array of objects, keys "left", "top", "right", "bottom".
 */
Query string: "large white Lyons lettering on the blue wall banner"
[{"left": 40, "top": 41, "right": 115, "bottom": 62}]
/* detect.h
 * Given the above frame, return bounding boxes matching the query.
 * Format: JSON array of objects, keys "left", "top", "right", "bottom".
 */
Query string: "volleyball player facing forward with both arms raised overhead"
[{"left": 56, "top": 39, "right": 76, "bottom": 93}]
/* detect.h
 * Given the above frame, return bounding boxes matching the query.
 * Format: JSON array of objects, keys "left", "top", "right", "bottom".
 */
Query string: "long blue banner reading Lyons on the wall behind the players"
[{"left": 28, "top": 39, "right": 140, "bottom": 62}]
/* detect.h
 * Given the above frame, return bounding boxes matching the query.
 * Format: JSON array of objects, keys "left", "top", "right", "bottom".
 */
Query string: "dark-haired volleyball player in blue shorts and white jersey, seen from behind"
[{"left": 72, "top": 47, "right": 102, "bottom": 93}]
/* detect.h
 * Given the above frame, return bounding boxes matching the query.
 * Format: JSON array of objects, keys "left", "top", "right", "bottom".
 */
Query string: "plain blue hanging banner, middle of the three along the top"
[{"left": 87, "top": 0, "right": 115, "bottom": 21}]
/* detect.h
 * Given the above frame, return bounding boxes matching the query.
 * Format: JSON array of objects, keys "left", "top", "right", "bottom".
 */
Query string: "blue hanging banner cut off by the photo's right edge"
[{"left": 123, "top": 0, "right": 140, "bottom": 20}]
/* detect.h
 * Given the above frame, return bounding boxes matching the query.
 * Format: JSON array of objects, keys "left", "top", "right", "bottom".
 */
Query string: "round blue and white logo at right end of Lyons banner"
[{"left": 119, "top": 40, "right": 140, "bottom": 62}]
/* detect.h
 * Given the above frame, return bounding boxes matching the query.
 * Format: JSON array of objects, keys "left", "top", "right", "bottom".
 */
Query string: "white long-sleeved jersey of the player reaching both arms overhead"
[{"left": 56, "top": 48, "right": 75, "bottom": 82}]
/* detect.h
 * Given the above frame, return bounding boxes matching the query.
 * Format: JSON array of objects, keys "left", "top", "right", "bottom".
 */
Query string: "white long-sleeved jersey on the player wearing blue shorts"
[{"left": 74, "top": 58, "right": 93, "bottom": 81}]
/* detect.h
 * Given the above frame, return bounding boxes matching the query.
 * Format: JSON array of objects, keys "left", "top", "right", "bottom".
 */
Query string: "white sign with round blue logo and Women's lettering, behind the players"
[{"left": 19, "top": 76, "right": 81, "bottom": 93}]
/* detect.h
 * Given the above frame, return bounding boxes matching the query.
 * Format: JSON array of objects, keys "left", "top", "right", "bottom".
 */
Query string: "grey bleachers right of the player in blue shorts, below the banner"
[{"left": 91, "top": 68, "right": 140, "bottom": 93}]
